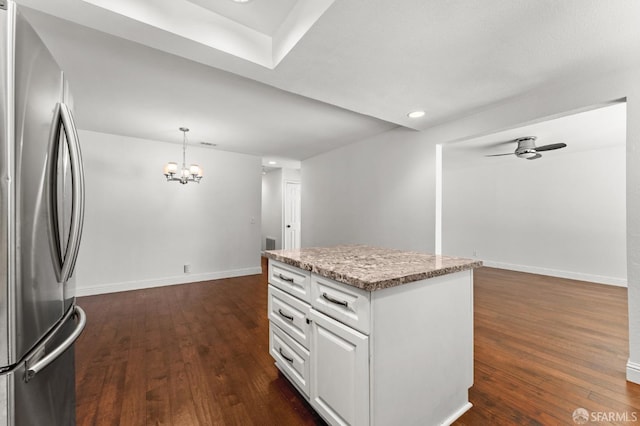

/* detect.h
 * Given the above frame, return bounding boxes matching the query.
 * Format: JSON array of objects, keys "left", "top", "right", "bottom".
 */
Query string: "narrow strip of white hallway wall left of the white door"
[{"left": 262, "top": 169, "right": 282, "bottom": 250}]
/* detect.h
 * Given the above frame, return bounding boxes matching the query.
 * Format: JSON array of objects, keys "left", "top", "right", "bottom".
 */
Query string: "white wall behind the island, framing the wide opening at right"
[{"left": 302, "top": 65, "right": 640, "bottom": 383}]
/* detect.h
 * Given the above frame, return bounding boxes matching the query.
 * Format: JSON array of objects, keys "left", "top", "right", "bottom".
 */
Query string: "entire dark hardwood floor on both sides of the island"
[{"left": 76, "top": 262, "right": 640, "bottom": 426}]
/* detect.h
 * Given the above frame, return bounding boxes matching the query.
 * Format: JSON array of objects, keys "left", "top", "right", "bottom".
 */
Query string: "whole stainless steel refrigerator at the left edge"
[{"left": 0, "top": 0, "right": 86, "bottom": 426}]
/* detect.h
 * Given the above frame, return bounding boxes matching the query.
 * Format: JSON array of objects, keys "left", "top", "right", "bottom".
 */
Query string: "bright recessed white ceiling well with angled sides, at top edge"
[{"left": 63, "top": 0, "right": 335, "bottom": 69}]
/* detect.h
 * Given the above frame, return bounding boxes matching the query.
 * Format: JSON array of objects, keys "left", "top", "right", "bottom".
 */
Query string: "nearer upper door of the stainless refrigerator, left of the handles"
[{"left": 9, "top": 3, "right": 64, "bottom": 364}]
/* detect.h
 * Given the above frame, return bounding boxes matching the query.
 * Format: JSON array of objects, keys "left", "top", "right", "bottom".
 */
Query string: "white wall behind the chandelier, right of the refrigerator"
[{"left": 76, "top": 131, "right": 261, "bottom": 295}]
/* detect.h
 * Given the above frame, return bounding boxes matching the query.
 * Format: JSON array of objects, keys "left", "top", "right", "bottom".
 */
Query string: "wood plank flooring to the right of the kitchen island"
[{"left": 457, "top": 268, "right": 640, "bottom": 425}]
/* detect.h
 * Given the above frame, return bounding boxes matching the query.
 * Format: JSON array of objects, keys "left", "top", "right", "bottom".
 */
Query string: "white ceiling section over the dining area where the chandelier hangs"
[{"left": 21, "top": 5, "right": 393, "bottom": 160}]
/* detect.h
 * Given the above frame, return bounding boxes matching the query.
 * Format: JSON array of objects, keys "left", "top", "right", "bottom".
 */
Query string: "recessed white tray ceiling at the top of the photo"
[{"left": 80, "top": 0, "right": 334, "bottom": 69}]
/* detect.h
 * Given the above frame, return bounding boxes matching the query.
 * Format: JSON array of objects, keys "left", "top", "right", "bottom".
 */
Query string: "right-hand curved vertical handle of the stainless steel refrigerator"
[{"left": 59, "top": 102, "right": 84, "bottom": 282}]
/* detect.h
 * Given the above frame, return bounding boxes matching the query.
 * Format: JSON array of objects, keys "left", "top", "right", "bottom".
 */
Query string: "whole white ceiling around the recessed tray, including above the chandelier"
[{"left": 18, "top": 0, "right": 640, "bottom": 160}]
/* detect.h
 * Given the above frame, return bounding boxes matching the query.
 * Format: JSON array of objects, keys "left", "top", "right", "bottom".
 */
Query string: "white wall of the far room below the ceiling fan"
[{"left": 442, "top": 145, "right": 627, "bottom": 285}]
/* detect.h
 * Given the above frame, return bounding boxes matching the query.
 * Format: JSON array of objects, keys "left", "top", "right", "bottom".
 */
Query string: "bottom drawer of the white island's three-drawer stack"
[{"left": 269, "top": 322, "right": 310, "bottom": 398}]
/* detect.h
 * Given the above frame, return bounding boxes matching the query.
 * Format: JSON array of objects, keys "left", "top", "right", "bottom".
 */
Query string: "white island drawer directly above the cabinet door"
[{"left": 311, "top": 274, "right": 371, "bottom": 335}]
